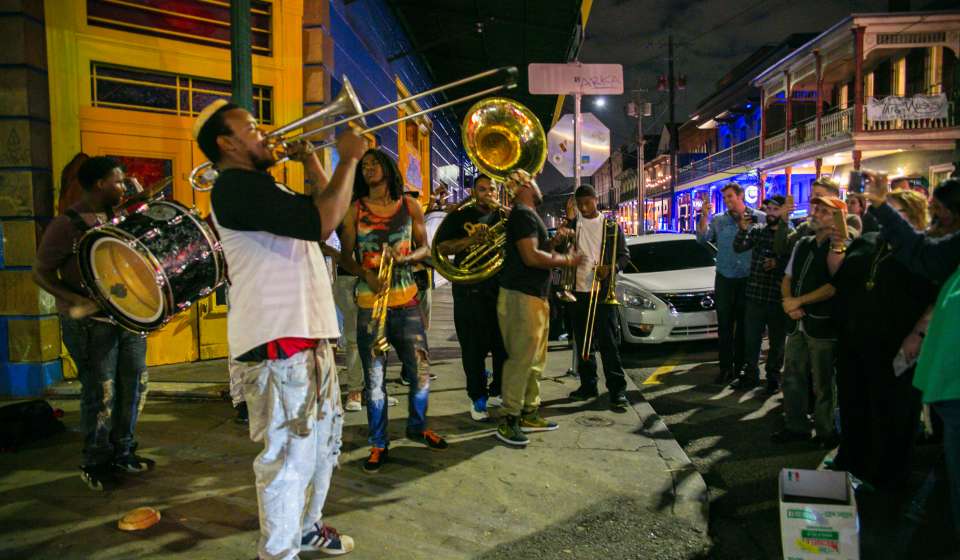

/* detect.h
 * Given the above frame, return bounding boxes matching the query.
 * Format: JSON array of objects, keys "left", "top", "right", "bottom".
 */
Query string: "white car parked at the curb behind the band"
[{"left": 617, "top": 233, "right": 717, "bottom": 344}]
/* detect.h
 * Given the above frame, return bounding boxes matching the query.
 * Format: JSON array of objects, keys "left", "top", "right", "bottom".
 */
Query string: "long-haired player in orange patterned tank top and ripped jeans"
[{"left": 341, "top": 150, "right": 447, "bottom": 473}]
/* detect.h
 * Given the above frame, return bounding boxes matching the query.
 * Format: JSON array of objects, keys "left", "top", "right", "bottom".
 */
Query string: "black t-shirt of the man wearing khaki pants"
[{"left": 500, "top": 203, "right": 550, "bottom": 298}]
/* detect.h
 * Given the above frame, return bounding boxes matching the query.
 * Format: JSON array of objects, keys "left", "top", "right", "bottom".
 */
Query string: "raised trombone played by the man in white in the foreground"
[{"left": 190, "top": 66, "right": 517, "bottom": 192}]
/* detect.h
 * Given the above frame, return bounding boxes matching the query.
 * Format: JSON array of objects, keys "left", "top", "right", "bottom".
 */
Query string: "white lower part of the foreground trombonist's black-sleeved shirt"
[{"left": 212, "top": 207, "right": 340, "bottom": 358}]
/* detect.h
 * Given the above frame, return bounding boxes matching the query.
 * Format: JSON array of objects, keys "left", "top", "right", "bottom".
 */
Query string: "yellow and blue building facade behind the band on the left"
[{"left": 0, "top": 0, "right": 470, "bottom": 395}]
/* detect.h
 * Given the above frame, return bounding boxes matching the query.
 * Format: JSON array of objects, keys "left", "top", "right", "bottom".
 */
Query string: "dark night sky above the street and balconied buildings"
[{"left": 539, "top": 0, "right": 932, "bottom": 197}]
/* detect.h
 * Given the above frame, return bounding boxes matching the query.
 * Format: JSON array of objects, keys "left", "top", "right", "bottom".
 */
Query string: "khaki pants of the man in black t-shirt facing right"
[{"left": 497, "top": 288, "right": 550, "bottom": 416}]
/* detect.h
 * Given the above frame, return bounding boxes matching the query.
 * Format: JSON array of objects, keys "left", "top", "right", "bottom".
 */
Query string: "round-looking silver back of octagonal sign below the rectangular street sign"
[{"left": 547, "top": 113, "right": 610, "bottom": 177}]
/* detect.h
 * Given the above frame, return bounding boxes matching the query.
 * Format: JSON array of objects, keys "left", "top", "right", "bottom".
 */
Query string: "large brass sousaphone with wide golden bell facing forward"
[{"left": 431, "top": 97, "right": 547, "bottom": 284}]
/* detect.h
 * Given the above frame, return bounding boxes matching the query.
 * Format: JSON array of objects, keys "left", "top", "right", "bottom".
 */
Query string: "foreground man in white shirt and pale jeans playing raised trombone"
[{"left": 194, "top": 100, "right": 364, "bottom": 560}]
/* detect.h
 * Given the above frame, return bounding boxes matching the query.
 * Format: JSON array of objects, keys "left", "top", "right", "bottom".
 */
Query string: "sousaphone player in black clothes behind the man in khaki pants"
[{"left": 433, "top": 174, "right": 507, "bottom": 422}]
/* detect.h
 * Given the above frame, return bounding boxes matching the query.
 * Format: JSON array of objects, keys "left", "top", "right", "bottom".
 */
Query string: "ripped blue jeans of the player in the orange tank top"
[{"left": 357, "top": 305, "right": 430, "bottom": 448}]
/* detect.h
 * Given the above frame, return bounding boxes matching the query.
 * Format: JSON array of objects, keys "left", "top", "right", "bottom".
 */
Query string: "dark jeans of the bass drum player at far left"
[{"left": 60, "top": 317, "right": 147, "bottom": 465}]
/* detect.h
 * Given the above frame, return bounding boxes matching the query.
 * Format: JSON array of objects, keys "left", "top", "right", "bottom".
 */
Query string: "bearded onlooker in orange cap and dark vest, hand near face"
[{"left": 773, "top": 196, "right": 846, "bottom": 448}]
